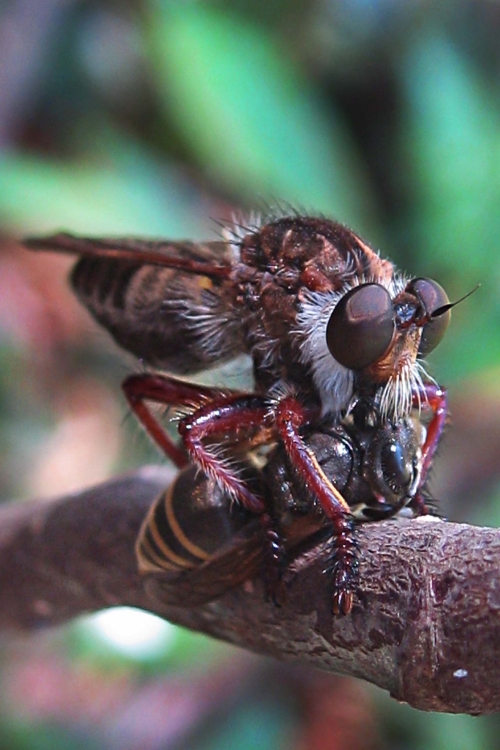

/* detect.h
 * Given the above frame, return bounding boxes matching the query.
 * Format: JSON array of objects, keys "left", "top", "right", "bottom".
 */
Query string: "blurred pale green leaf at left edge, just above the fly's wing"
[{"left": 0, "top": 151, "right": 203, "bottom": 237}]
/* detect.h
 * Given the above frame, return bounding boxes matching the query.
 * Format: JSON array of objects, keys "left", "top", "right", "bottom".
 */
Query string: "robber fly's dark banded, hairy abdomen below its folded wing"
[{"left": 71, "top": 257, "right": 242, "bottom": 374}]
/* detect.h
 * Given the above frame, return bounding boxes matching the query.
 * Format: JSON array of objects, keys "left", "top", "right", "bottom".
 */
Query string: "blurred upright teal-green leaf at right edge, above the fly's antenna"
[{"left": 403, "top": 35, "right": 500, "bottom": 280}]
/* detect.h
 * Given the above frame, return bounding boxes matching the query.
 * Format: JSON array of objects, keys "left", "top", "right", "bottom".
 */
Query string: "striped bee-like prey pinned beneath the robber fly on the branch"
[{"left": 136, "top": 406, "right": 438, "bottom": 606}]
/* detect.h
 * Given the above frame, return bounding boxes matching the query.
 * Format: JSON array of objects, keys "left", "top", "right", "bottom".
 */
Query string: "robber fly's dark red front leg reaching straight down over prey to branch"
[{"left": 275, "top": 397, "right": 358, "bottom": 615}]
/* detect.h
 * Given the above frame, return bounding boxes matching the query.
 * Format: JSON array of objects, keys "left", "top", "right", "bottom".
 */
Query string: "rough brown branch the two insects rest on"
[{"left": 0, "top": 468, "right": 500, "bottom": 714}]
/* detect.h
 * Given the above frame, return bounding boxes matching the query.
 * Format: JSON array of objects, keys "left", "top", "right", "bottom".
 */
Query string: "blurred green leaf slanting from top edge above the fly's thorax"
[{"left": 147, "top": 0, "right": 376, "bottom": 225}]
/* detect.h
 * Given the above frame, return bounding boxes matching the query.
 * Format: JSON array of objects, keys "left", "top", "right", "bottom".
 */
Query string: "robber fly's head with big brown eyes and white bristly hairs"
[{"left": 298, "top": 272, "right": 452, "bottom": 420}]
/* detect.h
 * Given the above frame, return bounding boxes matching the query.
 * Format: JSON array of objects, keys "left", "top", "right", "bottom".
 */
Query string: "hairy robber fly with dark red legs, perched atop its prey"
[{"left": 26, "top": 215, "right": 452, "bottom": 613}]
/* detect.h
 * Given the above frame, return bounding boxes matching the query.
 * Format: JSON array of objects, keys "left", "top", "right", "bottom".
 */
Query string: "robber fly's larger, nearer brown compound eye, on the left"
[{"left": 326, "top": 284, "right": 395, "bottom": 370}]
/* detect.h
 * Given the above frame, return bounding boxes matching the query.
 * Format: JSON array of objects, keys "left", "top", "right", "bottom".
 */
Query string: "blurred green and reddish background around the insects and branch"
[{"left": 0, "top": 0, "right": 500, "bottom": 750}]
